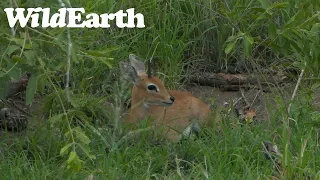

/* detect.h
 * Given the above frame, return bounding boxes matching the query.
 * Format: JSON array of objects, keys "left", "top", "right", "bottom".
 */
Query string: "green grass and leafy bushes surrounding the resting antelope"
[{"left": 0, "top": 0, "right": 320, "bottom": 179}]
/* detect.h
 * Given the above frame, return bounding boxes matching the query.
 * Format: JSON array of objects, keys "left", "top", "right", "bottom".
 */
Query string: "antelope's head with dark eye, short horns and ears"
[{"left": 120, "top": 54, "right": 174, "bottom": 107}]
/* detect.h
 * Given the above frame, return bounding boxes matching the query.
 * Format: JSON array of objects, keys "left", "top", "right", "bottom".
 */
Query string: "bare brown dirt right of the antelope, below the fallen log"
[{"left": 186, "top": 84, "right": 320, "bottom": 120}]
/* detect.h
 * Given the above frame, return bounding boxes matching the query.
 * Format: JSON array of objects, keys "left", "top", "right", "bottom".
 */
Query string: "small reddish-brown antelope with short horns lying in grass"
[{"left": 120, "top": 54, "right": 210, "bottom": 142}]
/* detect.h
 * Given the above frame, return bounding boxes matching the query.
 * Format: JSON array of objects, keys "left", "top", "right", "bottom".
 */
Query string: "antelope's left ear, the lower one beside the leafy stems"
[{"left": 119, "top": 61, "right": 141, "bottom": 86}]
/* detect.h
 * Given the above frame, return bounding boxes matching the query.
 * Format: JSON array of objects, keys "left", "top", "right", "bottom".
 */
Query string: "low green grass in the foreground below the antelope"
[{"left": 0, "top": 104, "right": 320, "bottom": 179}]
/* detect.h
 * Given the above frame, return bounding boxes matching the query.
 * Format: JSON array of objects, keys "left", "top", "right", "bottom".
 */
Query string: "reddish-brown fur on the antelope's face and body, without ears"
[{"left": 126, "top": 73, "right": 210, "bottom": 141}]
